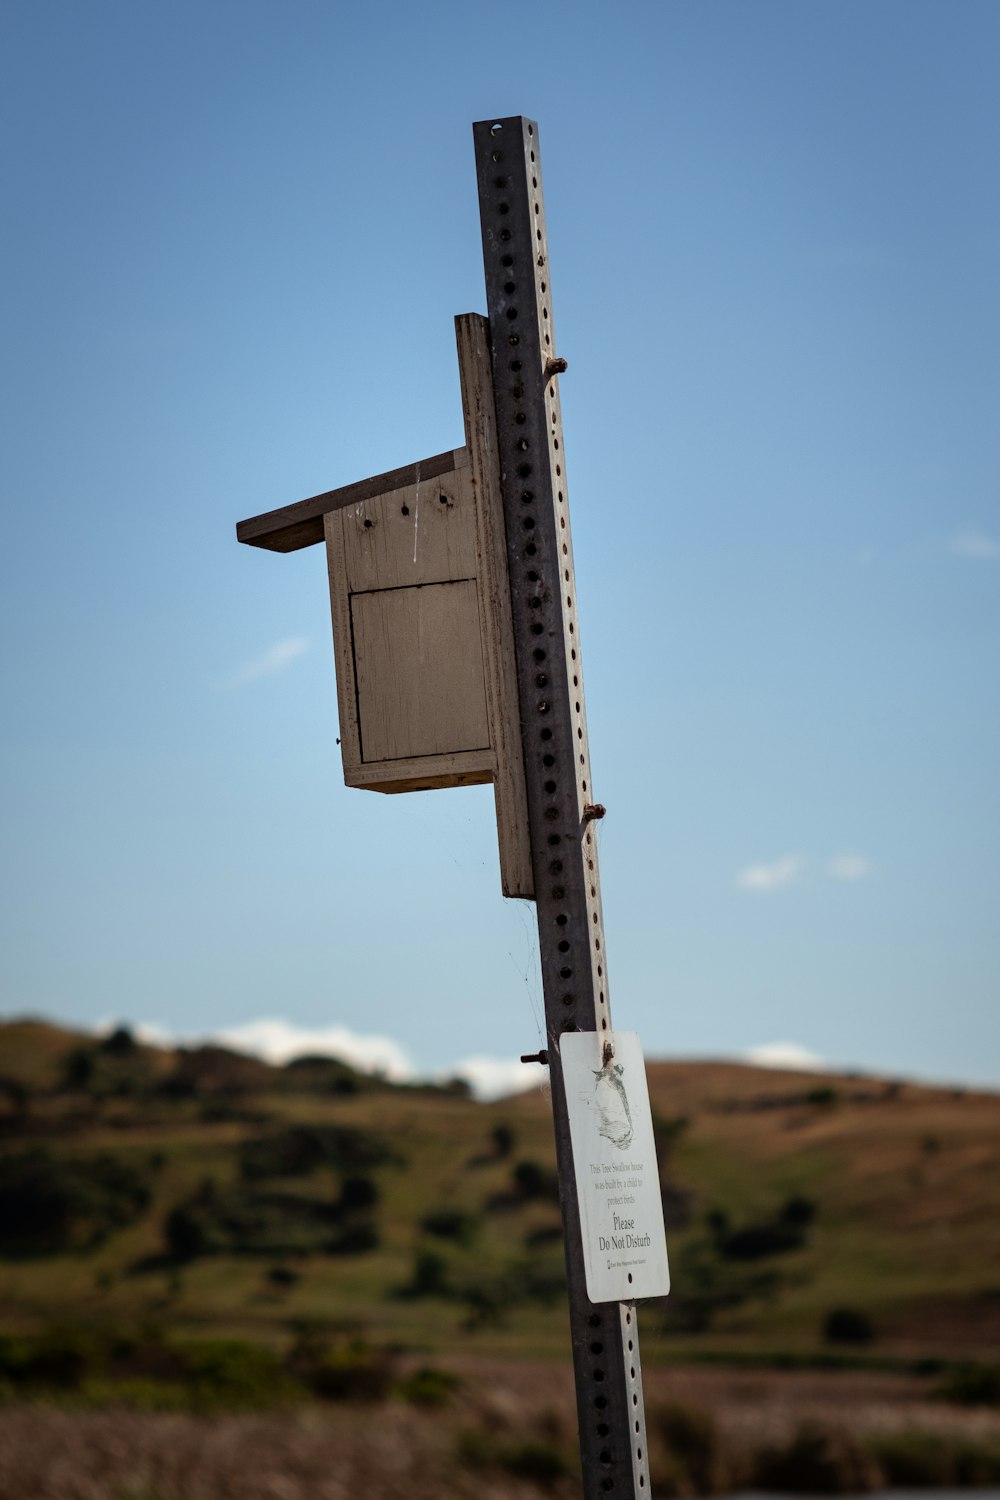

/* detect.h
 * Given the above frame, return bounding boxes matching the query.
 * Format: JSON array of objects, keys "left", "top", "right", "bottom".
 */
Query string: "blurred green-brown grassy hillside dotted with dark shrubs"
[{"left": 0, "top": 1022, "right": 1000, "bottom": 1364}]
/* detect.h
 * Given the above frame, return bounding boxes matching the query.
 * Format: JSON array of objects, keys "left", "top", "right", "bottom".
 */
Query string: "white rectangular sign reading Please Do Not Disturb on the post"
[{"left": 559, "top": 1032, "right": 670, "bottom": 1302}]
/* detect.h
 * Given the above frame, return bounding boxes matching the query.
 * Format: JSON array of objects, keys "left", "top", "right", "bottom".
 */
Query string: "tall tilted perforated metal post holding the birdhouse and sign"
[{"left": 474, "top": 116, "right": 649, "bottom": 1500}]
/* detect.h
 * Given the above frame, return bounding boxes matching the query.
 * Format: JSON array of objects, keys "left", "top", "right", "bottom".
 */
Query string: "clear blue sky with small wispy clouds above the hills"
[{"left": 0, "top": 0, "right": 1000, "bottom": 1085}]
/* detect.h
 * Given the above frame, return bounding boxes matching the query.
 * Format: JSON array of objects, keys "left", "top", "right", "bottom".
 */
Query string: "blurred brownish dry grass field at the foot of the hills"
[{"left": 0, "top": 1361, "right": 1000, "bottom": 1500}]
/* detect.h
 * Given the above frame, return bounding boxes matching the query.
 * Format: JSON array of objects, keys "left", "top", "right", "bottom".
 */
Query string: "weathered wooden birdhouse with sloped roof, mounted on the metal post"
[{"left": 238, "top": 314, "right": 534, "bottom": 897}]
